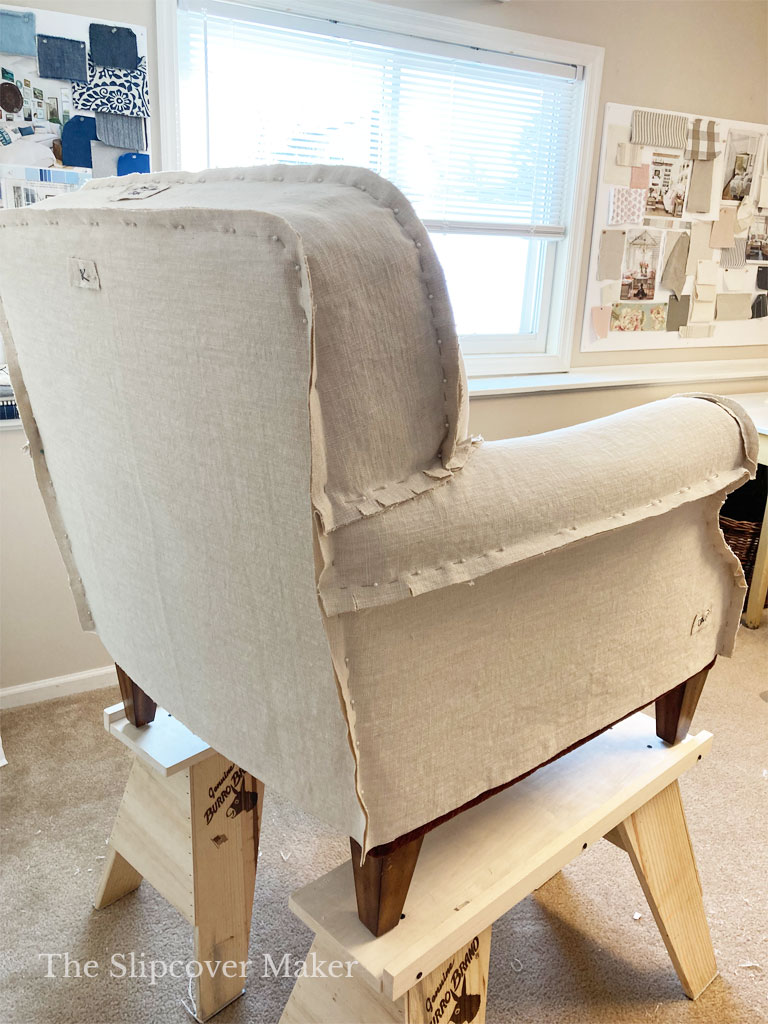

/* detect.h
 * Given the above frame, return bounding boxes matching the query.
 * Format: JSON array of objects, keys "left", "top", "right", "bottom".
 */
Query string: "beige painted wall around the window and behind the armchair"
[{"left": 0, "top": 0, "right": 768, "bottom": 686}]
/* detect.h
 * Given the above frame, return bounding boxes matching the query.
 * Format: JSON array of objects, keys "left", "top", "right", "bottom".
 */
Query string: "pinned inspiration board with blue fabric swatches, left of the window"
[{"left": 0, "top": 4, "right": 150, "bottom": 207}]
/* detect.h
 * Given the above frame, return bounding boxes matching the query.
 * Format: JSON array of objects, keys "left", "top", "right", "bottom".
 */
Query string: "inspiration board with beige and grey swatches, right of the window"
[{"left": 582, "top": 103, "right": 768, "bottom": 352}]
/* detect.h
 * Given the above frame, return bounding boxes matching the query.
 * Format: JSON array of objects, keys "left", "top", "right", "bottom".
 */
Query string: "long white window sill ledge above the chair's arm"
[{"left": 469, "top": 359, "right": 768, "bottom": 398}]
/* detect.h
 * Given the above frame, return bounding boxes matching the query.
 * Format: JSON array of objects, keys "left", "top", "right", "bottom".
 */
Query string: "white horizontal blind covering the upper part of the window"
[{"left": 179, "top": 2, "right": 581, "bottom": 233}]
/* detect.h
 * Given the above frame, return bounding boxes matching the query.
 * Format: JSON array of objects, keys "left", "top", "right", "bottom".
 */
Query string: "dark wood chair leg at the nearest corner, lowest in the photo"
[{"left": 349, "top": 836, "right": 424, "bottom": 937}]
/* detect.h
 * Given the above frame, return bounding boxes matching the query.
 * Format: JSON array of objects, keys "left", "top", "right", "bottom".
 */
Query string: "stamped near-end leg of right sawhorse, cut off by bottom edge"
[{"left": 280, "top": 928, "right": 490, "bottom": 1024}]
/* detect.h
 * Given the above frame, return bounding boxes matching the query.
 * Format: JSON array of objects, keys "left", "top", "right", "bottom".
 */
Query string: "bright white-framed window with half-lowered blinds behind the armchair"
[{"left": 171, "top": 0, "right": 606, "bottom": 374}]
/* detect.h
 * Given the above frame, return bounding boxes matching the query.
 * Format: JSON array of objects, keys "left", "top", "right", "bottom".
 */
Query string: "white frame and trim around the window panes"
[{"left": 156, "top": 0, "right": 604, "bottom": 378}]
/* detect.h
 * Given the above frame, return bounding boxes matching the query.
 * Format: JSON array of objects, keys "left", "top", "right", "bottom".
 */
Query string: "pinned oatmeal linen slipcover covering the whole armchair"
[{"left": 0, "top": 167, "right": 757, "bottom": 849}]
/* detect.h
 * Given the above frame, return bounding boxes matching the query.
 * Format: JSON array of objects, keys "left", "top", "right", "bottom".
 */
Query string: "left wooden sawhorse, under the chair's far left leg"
[{"left": 93, "top": 703, "right": 264, "bottom": 1021}]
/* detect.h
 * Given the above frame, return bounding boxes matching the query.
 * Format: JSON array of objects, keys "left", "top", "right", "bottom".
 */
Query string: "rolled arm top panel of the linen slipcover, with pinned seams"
[{"left": 319, "top": 395, "right": 757, "bottom": 615}]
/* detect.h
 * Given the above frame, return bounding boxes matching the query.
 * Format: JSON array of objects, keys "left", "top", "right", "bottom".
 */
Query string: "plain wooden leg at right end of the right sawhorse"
[{"left": 611, "top": 780, "right": 718, "bottom": 999}]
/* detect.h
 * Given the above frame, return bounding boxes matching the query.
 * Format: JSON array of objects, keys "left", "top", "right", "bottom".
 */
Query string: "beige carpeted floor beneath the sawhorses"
[{"left": 0, "top": 615, "right": 768, "bottom": 1024}]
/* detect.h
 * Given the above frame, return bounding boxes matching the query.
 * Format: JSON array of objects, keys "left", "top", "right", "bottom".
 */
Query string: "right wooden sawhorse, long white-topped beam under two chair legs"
[{"left": 281, "top": 714, "right": 718, "bottom": 1024}]
